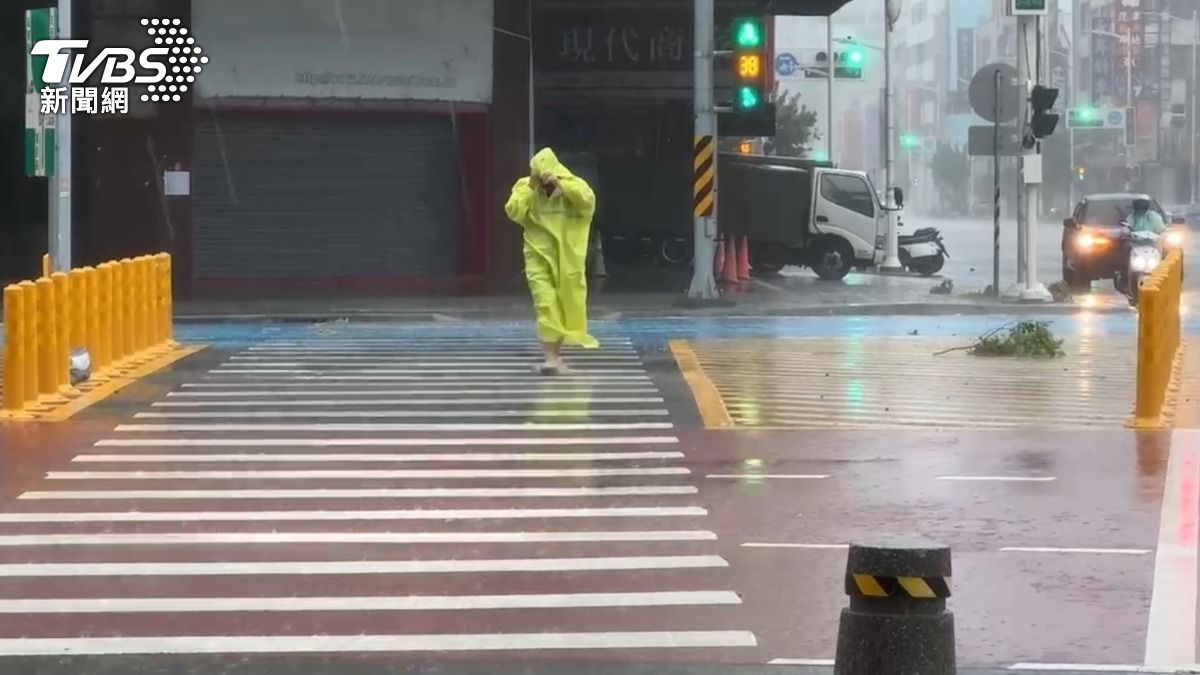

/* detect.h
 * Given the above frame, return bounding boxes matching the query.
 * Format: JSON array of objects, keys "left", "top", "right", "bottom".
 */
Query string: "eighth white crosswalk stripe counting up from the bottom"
[{"left": 71, "top": 452, "right": 684, "bottom": 464}]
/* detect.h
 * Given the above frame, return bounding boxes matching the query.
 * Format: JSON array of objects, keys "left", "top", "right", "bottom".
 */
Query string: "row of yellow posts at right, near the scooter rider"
[{"left": 1129, "top": 250, "right": 1183, "bottom": 429}]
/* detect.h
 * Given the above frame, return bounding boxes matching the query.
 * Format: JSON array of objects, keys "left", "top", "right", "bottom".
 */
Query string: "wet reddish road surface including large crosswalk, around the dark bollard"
[{"left": 0, "top": 330, "right": 1196, "bottom": 673}]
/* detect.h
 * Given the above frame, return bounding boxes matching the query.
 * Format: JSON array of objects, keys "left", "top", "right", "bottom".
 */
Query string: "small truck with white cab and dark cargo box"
[{"left": 716, "top": 153, "right": 904, "bottom": 280}]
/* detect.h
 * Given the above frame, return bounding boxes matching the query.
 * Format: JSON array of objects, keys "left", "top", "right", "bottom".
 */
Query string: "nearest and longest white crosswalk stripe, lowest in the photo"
[{"left": 0, "top": 631, "right": 758, "bottom": 656}]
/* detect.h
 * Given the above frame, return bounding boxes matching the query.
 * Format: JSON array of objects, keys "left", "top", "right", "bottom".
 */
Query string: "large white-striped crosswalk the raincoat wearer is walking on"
[{"left": 0, "top": 330, "right": 756, "bottom": 661}]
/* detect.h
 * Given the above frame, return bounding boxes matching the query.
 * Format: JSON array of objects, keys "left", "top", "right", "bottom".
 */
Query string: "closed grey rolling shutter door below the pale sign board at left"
[{"left": 192, "top": 112, "right": 461, "bottom": 280}]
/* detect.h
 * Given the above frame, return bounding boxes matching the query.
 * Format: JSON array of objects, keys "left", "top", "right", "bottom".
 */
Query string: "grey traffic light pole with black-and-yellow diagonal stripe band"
[{"left": 688, "top": 0, "right": 719, "bottom": 300}]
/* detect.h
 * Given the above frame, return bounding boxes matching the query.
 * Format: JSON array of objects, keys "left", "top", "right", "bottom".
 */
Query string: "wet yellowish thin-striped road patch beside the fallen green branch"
[{"left": 673, "top": 335, "right": 1136, "bottom": 429}]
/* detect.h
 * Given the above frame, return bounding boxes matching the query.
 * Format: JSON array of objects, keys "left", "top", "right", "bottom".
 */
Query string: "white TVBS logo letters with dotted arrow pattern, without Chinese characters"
[{"left": 31, "top": 18, "right": 209, "bottom": 101}]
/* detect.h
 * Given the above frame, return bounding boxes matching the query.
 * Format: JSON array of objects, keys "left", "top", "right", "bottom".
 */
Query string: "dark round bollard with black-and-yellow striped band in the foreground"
[{"left": 834, "top": 542, "right": 956, "bottom": 675}]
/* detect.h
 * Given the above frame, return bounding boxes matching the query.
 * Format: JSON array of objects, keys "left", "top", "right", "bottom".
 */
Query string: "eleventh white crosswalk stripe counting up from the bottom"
[{"left": 133, "top": 408, "right": 671, "bottom": 419}]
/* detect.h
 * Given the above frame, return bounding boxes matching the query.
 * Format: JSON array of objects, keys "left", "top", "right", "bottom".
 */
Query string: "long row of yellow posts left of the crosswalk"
[{"left": 0, "top": 253, "right": 174, "bottom": 419}]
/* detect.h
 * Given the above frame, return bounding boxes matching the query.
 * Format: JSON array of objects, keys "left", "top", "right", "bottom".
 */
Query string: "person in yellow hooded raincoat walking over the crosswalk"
[{"left": 504, "top": 148, "right": 600, "bottom": 375}]
